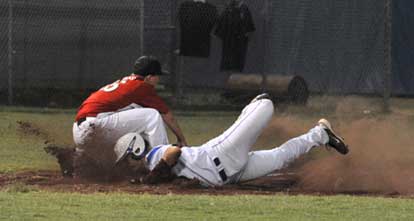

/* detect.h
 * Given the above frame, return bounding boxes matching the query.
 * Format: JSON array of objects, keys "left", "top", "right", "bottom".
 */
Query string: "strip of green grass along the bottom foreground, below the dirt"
[{"left": 0, "top": 191, "right": 414, "bottom": 221}]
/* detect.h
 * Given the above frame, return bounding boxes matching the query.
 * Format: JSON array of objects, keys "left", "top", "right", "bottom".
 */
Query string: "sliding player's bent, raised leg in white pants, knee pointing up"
[{"left": 202, "top": 94, "right": 274, "bottom": 176}]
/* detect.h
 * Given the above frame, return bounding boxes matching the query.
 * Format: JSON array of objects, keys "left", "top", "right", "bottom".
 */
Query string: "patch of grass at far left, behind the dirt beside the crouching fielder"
[{"left": 0, "top": 111, "right": 72, "bottom": 172}]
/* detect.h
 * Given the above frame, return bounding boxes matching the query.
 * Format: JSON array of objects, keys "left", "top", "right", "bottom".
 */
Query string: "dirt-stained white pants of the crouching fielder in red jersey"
[{"left": 73, "top": 108, "right": 169, "bottom": 160}]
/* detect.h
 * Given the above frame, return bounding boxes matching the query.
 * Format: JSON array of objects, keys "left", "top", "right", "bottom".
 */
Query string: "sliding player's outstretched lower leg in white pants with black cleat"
[{"left": 239, "top": 121, "right": 348, "bottom": 181}]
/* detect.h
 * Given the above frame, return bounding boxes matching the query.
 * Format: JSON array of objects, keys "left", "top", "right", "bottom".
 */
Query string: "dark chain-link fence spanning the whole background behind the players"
[{"left": 0, "top": 0, "right": 414, "bottom": 108}]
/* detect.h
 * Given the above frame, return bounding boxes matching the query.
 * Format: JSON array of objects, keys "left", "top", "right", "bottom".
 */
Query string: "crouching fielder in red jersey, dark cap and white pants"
[{"left": 73, "top": 56, "right": 187, "bottom": 177}]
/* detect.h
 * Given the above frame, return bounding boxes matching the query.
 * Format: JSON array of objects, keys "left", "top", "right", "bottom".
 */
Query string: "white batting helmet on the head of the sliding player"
[{"left": 114, "top": 133, "right": 146, "bottom": 163}]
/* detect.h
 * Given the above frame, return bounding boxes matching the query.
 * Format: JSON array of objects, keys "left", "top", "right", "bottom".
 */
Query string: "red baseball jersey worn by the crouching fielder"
[{"left": 75, "top": 74, "right": 169, "bottom": 121}]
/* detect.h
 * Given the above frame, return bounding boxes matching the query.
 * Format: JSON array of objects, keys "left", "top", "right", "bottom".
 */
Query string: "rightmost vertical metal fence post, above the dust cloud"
[{"left": 383, "top": 0, "right": 392, "bottom": 112}]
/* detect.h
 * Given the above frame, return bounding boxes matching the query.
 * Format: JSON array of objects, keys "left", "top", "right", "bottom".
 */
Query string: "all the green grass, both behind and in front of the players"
[{"left": 0, "top": 97, "right": 414, "bottom": 220}]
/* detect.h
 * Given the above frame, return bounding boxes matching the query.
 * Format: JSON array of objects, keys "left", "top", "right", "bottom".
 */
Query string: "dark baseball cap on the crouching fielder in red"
[{"left": 134, "top": 56, "right": 169, "bottom": 77}]
